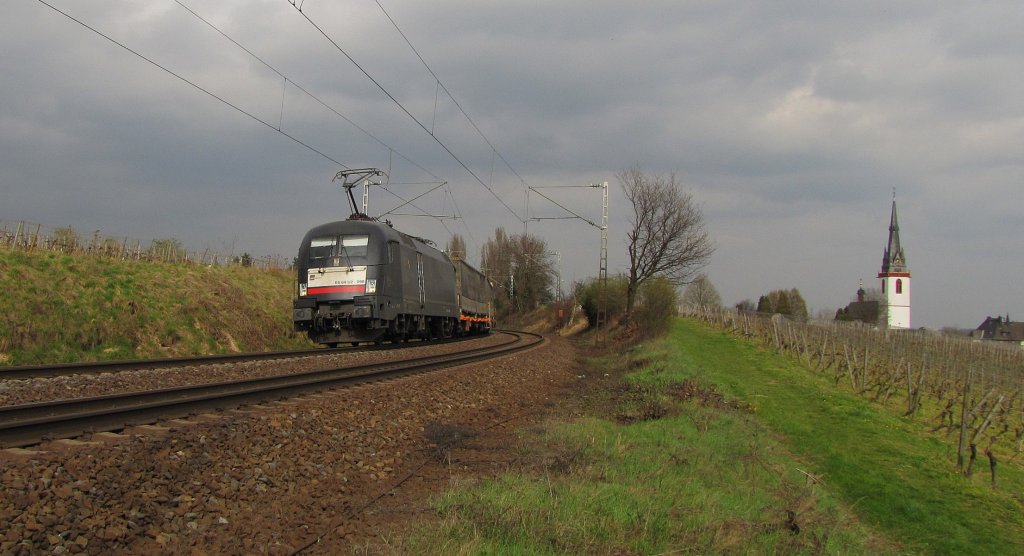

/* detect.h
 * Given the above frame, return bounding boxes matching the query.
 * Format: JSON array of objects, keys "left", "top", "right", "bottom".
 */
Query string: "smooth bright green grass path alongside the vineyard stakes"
[{"left": 668, "top": 322, "right": 1024, "bottom": 554}]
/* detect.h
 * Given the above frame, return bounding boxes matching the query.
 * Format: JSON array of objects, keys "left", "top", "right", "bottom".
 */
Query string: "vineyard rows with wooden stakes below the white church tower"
[{"left": 691, "top": 309, "right": 1024, "bottom": 466}]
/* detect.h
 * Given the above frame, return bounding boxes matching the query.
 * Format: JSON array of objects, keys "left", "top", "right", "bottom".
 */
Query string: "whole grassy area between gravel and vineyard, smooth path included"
[{"left": 410, "top": 322, "right": 1024, "bottom": 554}]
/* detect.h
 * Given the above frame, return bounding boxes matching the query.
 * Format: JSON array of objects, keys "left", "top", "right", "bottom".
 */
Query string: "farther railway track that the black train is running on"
[{"left": 0, "top": 339, "right": 461, "bottom": 380}]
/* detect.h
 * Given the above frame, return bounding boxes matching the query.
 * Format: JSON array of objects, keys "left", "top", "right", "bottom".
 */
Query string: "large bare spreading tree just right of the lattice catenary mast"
[{"left": 616, "top": 165, "right": 715, "bottom": 315}]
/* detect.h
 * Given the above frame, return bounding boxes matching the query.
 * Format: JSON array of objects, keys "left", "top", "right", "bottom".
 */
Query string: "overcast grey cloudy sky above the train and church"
[{"left": 0, "top": 0, "right": 1024, "bottom": 328}]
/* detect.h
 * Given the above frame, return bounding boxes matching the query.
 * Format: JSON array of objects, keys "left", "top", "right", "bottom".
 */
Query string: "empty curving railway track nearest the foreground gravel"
[{"left": 0, "top": 332, "right": 543, "bottom": 447}]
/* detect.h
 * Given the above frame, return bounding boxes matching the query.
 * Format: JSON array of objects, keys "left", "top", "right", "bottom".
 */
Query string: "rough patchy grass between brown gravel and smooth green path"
[{"left": 408, "top": 331, "right": 902, "bottom": 554}]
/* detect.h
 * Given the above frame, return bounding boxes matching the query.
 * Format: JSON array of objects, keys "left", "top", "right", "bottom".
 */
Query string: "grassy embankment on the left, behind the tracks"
[{"left": 0, "top": 250, "right": 310, "bottom": 365}]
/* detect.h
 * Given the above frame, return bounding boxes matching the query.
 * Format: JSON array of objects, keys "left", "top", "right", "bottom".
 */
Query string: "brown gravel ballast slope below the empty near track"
[{"left": 0, "top": 338, "right": 574, "bottom": 554}]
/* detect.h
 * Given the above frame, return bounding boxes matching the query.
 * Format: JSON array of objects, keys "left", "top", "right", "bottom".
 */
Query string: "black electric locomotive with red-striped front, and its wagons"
[{"left": 293, "top": 214, "right": 493, "bottom": 346}]
